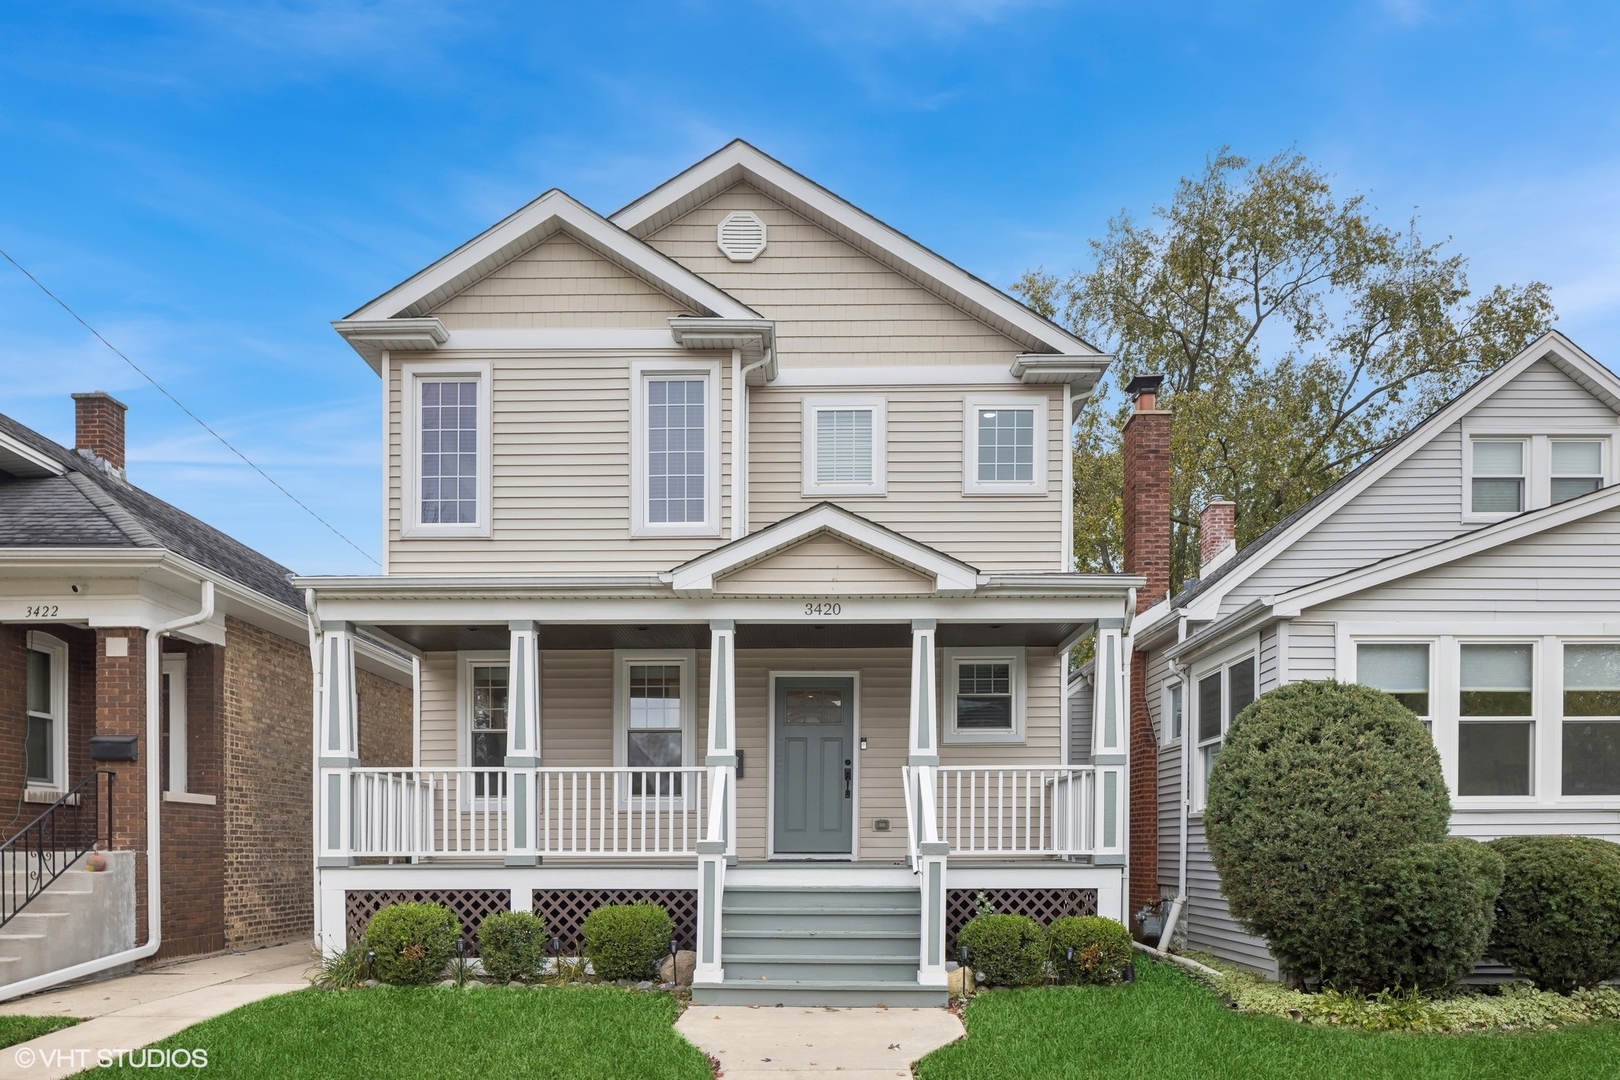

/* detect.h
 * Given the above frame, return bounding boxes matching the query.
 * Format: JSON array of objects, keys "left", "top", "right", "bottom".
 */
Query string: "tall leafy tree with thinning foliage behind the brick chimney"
[{"left": 1014, "top": 149, "right": 1555, "bottom": 583}]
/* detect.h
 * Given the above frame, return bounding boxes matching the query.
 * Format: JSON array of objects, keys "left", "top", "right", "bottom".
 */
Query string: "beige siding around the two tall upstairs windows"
[{"left": 387, "top": 351, "right": 731, "bottom": 573}]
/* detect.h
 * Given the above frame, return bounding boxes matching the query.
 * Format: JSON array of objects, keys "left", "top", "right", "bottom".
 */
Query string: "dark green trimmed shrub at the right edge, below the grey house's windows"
[{"left": 1490, "top": 836, "right": 1620, "bottom": 994}]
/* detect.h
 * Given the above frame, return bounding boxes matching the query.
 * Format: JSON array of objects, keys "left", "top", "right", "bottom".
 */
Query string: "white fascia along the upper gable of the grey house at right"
[{"left": 1187, "top": 330, "right": 1620, "bottom": 619}]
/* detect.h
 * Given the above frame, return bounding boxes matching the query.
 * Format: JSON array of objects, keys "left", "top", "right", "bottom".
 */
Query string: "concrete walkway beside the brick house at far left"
[{"left": 0, "top": 942, "right": 313, "bottom": 1080}]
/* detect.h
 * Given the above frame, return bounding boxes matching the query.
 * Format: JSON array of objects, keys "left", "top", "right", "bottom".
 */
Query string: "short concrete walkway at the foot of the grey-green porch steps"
[{"left": 676, "top": 1006, "right": 964, "bottom": 1080}]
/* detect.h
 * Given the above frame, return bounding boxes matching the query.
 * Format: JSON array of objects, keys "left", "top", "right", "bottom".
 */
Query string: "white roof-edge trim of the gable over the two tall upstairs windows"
[{"left": 332, "top": 188, "right": 760, "bottom": 368}]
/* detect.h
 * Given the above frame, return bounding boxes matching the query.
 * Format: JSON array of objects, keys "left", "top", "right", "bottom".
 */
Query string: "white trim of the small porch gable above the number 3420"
[{"left": 671, "top": 505, "right": 978, "bottom": 596}]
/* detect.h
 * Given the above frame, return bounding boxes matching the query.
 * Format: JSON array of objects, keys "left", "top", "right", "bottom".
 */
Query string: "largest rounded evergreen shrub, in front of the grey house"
[{"left": 1204, "top": 682, "right": 1452, "bottom": 983}]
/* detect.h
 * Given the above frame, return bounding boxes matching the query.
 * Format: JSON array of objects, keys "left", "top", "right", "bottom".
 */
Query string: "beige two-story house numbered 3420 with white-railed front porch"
[{"left": 298, "top": 142, "right": 1144, "bottom": 1004}]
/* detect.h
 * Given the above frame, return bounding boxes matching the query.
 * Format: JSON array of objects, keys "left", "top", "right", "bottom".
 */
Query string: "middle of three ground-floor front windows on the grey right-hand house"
[{"left": 1456, "top": 643, "right": 1536, "bottom": 797}]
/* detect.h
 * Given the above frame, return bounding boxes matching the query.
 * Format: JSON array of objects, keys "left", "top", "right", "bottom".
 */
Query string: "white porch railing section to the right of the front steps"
[{"left": 933, "top": 766, "right": 1097, "bottom": 857}]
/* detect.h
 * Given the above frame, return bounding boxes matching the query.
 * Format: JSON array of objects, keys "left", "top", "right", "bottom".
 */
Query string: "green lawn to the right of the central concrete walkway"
[{"left": 917, "top": 960, "right": 1620, "bottom": 1080}]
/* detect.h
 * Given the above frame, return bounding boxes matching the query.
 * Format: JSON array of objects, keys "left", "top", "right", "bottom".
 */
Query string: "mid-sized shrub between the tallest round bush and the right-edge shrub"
[{"left": 1327, "top": 837, "right": 1502, "bottom": 993}]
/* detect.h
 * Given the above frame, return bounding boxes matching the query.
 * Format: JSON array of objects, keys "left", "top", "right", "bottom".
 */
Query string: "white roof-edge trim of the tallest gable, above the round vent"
[{"left": 609, "top": 139, "right": 1106, "bottom": 359}]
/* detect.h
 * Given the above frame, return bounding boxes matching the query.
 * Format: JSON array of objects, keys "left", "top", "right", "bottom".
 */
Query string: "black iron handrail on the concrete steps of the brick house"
[{"left": 0, "top": 769, "right": 115, "bottom": 926}]
